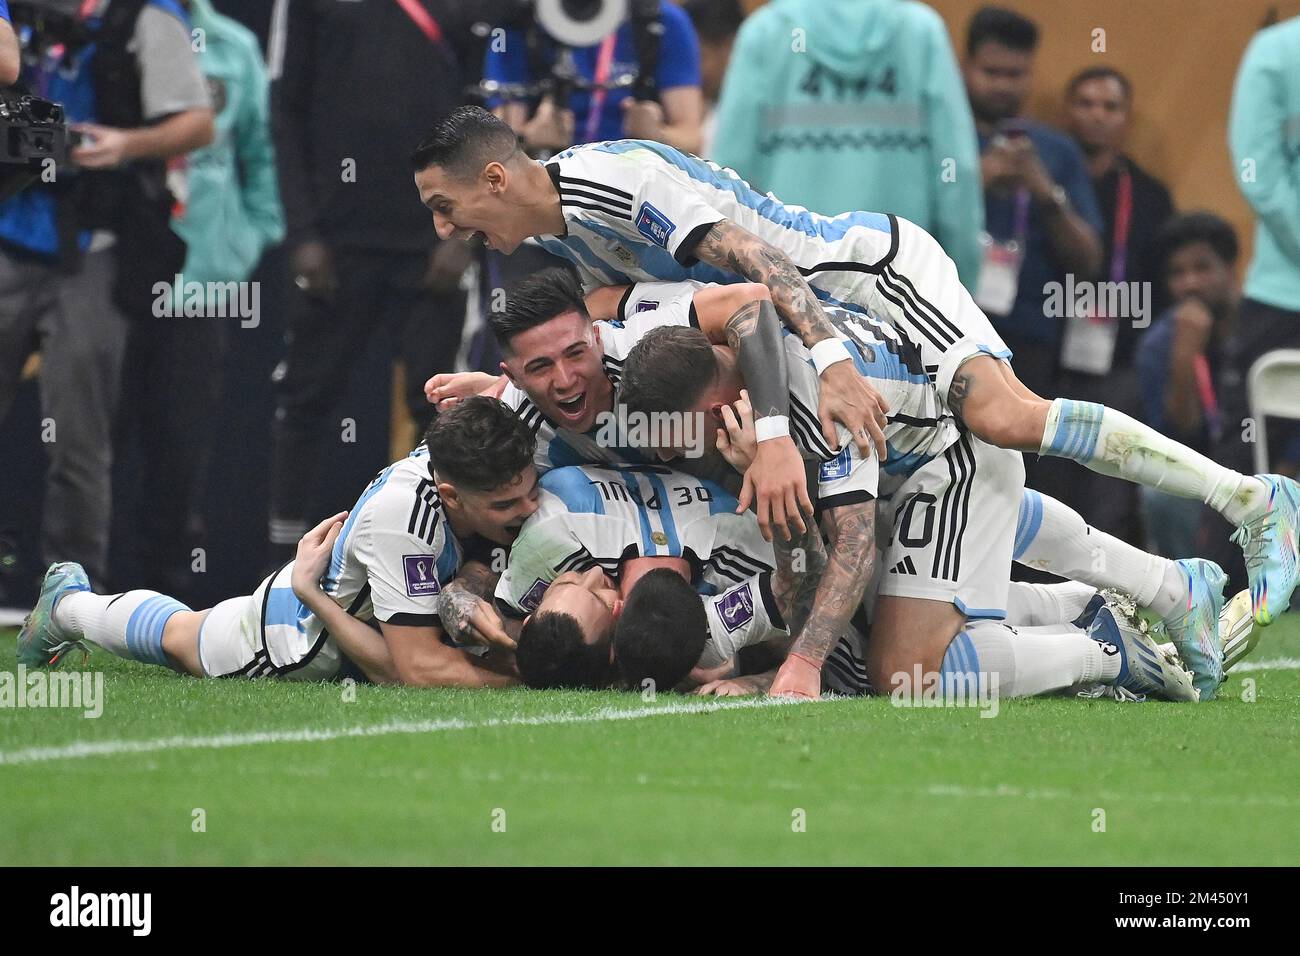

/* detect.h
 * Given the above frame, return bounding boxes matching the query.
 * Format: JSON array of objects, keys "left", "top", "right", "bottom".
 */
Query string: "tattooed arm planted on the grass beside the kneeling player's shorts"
[{"left": 771, "top": 501, "right": 876, "bottom": 697}]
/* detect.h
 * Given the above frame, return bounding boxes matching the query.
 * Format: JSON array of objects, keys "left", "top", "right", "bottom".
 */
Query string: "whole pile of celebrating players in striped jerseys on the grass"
[{"left": 18, "top": 108, "right": 1300, "bottom": 701}]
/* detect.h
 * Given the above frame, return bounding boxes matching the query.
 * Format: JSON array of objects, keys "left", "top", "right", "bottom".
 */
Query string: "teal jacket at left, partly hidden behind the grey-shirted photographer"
[{"left": 172, "top": 0, "right": 285, "bottom": 295}]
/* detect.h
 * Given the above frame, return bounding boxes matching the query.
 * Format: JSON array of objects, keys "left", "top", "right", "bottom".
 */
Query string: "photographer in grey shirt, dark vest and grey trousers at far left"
[{"left": 0, "top": 0, "right": 213, "bottom": 590}]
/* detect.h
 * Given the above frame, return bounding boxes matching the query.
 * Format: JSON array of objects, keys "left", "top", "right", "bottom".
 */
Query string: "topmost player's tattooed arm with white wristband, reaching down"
[{"left": 692, "top": 220, "right": 889, "bottom": 460}]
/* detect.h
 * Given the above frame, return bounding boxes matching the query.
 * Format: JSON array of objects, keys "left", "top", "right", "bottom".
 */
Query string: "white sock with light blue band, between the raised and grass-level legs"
[{"left": 1013, "top": 489, "right": 1188, "bottom": 618}]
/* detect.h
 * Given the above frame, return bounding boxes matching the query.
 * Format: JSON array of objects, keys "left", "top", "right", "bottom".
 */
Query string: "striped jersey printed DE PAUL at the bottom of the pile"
[{"left": 497, "top": 466, "right": 785, "bottom": 666}]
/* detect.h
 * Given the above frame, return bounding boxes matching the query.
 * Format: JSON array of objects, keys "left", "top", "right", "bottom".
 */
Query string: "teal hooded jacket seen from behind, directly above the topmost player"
[{"left": 710, "top": 0, "right": 984, "bottom": 289}]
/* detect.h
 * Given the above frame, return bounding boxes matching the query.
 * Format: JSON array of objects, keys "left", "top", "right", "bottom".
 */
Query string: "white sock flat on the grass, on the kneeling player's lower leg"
[{"left": 943, "top": 620, "right": 1119, "bottom": 697}]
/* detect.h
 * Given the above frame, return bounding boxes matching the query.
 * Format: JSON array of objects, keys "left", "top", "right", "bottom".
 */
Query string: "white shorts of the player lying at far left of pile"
[{"left": 199, "top": 564, "right": 341, "bottom": 680}]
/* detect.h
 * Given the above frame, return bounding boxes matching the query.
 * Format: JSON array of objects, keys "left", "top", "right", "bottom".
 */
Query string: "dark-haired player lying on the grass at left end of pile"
[{"left": 18, "top": 398, "right": 537, "bottom": 687}]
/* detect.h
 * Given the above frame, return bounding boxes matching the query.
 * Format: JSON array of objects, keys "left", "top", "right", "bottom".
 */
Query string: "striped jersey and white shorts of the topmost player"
[{"left": 537, "top": 139, "right": 1010, "bottom": 395}]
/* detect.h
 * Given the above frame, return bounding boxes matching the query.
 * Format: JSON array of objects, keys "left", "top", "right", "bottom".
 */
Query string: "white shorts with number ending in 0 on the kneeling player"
[{"left": 878, "top": 432, "right": 1024, "bottom": 619}]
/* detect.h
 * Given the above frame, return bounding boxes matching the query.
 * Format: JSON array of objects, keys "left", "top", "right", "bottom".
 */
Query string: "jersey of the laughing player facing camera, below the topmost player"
[{"left": 501, "top": 282, "right": 697, "bottom": 475}]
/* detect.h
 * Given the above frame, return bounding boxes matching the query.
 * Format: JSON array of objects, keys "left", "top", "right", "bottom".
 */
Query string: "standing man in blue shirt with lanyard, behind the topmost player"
[{"left": 965, "top": 7, "right": 1101, "bottom": 397}]
